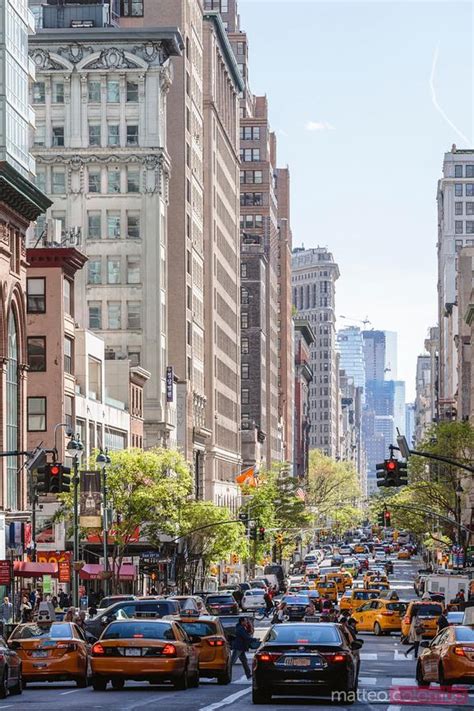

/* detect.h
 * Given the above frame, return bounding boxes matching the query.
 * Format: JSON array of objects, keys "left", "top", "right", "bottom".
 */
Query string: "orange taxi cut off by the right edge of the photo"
[{"left": 416, "top": 625, "right": 474, "bottom": 686}]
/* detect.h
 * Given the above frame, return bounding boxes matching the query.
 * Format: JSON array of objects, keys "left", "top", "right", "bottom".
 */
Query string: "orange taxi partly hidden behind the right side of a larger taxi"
[{"left": 178, "top": 615, "right": 232, "bottom": 684}]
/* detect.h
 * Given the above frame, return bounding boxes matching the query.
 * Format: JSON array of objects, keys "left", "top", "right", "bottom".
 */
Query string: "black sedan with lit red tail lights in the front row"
[{"left": 252, "top": 622, "right": 363, "bottom": 704}]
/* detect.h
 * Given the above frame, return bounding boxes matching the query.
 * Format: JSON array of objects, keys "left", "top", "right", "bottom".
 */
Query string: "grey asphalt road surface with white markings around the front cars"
[{"left": 0, "top": 560, "right": 474, "bottom": 711}]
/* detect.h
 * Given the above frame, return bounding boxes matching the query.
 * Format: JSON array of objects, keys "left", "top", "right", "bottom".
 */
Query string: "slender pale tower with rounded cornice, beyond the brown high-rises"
[{"left": 292, "top": 247, "right": 339, "bottom": 457}]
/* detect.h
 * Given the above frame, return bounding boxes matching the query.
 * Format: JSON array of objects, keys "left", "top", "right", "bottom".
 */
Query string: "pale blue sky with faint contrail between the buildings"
[{"left": 239, "top": 0, "right": 474, "bottom": 398}]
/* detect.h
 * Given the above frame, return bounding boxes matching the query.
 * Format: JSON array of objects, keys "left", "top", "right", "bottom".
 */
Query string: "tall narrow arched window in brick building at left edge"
[{"left": 6, "top": 309, "right": 20, "bottom": 509}]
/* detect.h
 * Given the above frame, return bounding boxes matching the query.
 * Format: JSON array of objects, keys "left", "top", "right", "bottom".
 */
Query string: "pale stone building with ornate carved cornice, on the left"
[{"left": 30, "top": 19, "right": 182, "bottom": 446}]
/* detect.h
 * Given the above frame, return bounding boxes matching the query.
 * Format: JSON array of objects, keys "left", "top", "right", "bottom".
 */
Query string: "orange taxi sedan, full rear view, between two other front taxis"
[{"left": 91, "top": 619, "right": 199, "bottom": 691}]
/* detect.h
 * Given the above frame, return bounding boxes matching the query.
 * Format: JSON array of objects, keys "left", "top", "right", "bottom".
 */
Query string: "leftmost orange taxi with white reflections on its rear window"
[{"left": 8, "top": 621, "right": 90, "bottom": 689}]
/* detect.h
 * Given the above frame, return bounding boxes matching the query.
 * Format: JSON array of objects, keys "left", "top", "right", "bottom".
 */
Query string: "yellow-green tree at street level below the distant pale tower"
[{"left": 306, "top": 449, "right": 363, "bottom": 535}]
